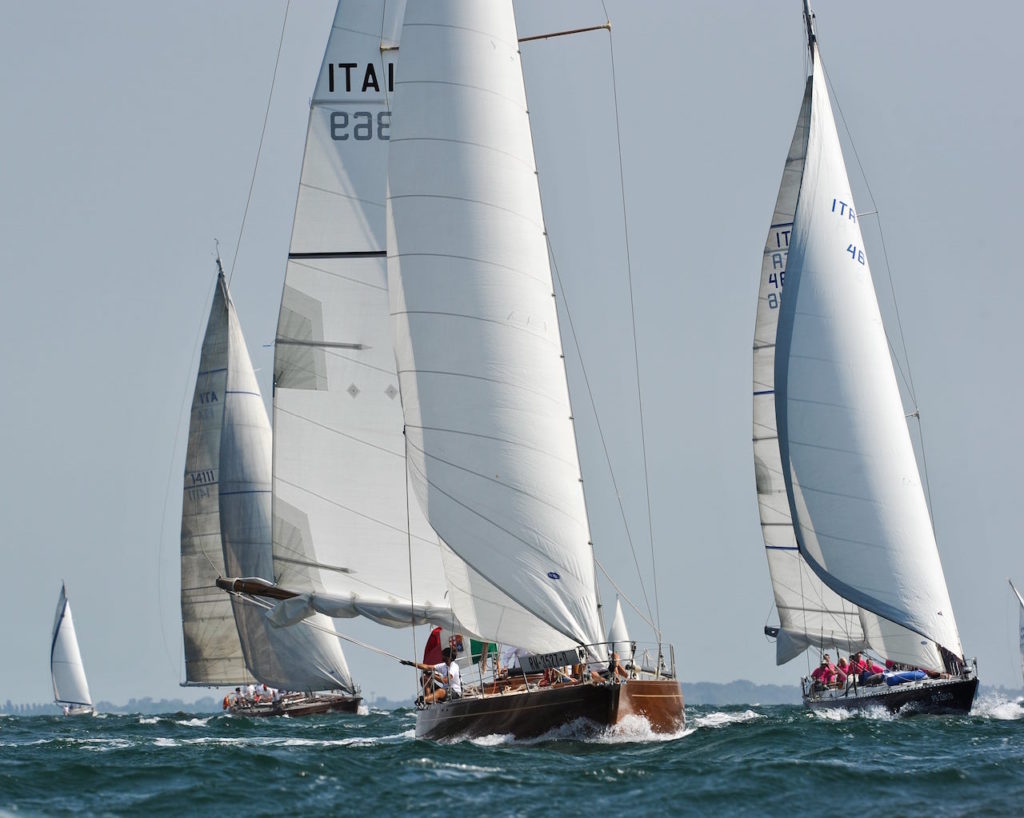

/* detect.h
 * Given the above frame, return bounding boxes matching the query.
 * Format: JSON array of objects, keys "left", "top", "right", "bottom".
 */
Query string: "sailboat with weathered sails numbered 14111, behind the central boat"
[{"left": 181, "top": 258, "right": 360, "bottom": 716}]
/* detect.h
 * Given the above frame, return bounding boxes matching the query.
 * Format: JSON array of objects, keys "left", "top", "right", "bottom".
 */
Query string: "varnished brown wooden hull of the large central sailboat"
[{"left": 416, "top": 680, "right": 685, "bottom": 739}]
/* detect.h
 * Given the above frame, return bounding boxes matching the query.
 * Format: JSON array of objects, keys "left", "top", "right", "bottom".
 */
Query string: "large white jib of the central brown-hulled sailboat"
[{"left": 388, "top": 0, "right": 603, "bottom": 644}]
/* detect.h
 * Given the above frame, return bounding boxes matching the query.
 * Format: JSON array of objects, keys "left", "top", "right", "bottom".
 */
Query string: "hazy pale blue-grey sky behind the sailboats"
[{"left": 0, "top": 0, "right": 1024, "bottom": 702}]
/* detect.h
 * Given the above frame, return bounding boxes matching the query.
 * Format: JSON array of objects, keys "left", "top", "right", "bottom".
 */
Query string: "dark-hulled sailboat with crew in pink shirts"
[{"left": 754, "top": 0, "right": 978, "bottom": 712}]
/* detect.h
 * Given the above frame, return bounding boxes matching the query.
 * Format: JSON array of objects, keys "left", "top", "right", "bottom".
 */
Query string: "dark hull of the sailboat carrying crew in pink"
[{"left": 804, "top": 677, "right": 978, "bottom": 716}]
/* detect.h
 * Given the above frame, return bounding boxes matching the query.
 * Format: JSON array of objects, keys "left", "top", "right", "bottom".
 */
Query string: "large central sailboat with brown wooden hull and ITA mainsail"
[{"left": 219, "top": 0, "right": 683, "bottom": 738}]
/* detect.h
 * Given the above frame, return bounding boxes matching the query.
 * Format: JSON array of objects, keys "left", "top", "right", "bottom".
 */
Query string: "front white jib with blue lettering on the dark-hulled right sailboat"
[{"left": 775, "top": 46, "right": 963, "bottom": 669}]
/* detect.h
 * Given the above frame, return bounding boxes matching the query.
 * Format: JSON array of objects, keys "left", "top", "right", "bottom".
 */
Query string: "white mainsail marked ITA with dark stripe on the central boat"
[{"left": 273, "top": 0, "right": 564, "bottom": 650}]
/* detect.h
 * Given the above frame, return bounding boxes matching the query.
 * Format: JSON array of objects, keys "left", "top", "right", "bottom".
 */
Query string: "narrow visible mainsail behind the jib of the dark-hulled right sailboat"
[{"left": 754, "top": 78, "right": 866, "bottom": 664}]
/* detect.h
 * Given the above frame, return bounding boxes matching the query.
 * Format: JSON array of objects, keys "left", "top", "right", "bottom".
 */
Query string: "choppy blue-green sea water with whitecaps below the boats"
[{"left": 0, "top": 698, "right": 1024, "bottom": 818}]
